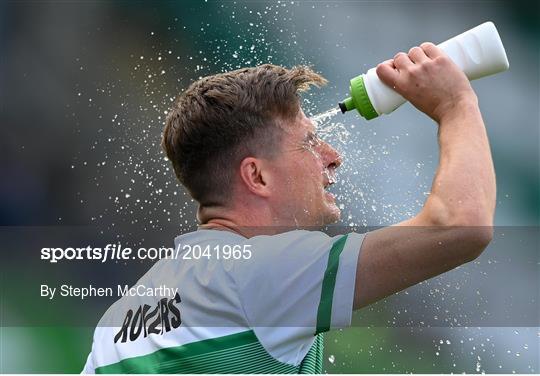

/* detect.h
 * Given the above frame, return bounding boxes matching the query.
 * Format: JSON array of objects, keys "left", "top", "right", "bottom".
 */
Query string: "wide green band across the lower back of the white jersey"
[{"left": 96, "top": 330, "right": 323, "bottom": 373}]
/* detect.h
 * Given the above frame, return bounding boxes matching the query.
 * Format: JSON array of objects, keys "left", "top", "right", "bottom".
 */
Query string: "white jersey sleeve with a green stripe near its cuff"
[{"left": 233, "top": 230, "right": 364, "bottom": 365}]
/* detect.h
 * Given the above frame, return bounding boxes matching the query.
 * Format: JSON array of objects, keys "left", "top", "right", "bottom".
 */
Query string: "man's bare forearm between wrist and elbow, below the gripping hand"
[{"left": 422, "top": 96, "right": 496, "bottom": 226}]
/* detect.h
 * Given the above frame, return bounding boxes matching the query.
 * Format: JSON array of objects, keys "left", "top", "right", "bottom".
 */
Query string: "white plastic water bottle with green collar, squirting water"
[{"left": 339, "top": 22, "right": 509, "bottom": 120}]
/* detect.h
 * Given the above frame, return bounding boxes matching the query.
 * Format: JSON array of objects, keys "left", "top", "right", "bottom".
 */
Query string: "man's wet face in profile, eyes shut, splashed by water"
[{"left": 273, "top": 110, "right": 341, "bottom": 226}]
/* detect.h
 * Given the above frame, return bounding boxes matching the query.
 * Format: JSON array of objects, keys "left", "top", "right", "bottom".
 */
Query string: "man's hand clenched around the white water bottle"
[{"left": 377, "top": 43, "right": 476, "bottom": 123}]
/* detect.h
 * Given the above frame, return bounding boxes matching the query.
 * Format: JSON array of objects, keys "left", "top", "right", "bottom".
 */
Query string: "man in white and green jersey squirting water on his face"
[{"left": 84, "top": 43, "right": 495, "bottom": 373}]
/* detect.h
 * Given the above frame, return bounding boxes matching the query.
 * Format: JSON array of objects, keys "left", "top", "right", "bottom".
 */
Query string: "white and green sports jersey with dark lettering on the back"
[{"left": 83, "top": 230, "right": 364, "bottom": 373}]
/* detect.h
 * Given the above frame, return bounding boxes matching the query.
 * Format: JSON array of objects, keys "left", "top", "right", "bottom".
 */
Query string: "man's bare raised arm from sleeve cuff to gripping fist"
[{"left": 354, "top": 43, "right": 496, "bottom": 309}]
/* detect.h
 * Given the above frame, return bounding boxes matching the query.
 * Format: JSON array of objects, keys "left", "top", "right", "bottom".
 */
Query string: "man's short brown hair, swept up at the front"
[{"left": 161, "top": 64, "right": 326, "bottom": 205}]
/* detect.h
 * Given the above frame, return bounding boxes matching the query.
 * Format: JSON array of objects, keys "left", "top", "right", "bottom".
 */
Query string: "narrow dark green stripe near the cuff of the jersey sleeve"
[{"left": 315, "top": 235, "right": 347, "bottom": 334}]
